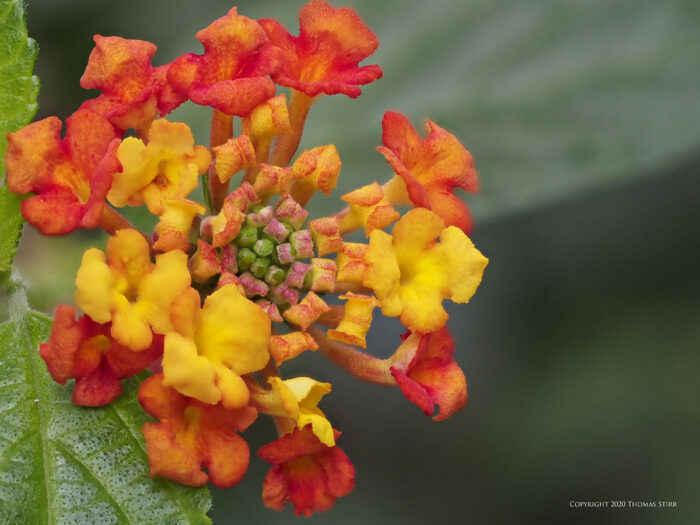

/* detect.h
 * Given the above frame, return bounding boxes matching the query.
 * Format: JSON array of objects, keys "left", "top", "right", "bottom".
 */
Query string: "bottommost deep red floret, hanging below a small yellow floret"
[{"left": 258, "top": 426, "right": 355, "bottom": 516}]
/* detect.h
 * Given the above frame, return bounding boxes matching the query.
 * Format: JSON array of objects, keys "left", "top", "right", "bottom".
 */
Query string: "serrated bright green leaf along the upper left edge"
[{"left": 0, "top": 0, "right": 39, "bottom": 275}]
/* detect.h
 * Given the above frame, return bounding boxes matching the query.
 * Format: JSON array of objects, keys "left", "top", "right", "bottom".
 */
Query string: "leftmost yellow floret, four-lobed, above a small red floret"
[{"left": 75, "top": 230, "right": 190, "bottom": 351}]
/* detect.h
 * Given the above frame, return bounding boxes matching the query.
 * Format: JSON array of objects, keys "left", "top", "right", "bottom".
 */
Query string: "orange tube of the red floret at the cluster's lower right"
[{"left": 307, "top": 325, "right": 396, "bottom": 386}]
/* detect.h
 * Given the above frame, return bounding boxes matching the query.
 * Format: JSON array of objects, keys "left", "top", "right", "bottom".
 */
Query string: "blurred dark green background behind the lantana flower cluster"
[{"left": 10, "top": 0, "right": 700, "bottom": 524}]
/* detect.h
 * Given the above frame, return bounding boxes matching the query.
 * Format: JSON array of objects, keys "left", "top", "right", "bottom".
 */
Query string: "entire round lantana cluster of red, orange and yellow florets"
[{"left": 6, "top": 1, "right": 487, "bottom": 515}]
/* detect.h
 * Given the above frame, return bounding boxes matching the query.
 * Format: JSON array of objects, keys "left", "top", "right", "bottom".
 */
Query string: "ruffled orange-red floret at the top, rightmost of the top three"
[{"left": 260, "top": 2, "right": 382, "bottom": 98}]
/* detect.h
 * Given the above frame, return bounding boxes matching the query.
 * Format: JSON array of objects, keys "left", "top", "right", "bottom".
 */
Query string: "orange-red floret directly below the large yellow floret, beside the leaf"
[{"left": 139, "top": 374, "right": 257, "bottom": 488}]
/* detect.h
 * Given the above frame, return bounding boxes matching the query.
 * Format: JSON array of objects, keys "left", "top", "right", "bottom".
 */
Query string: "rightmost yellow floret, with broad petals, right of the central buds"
[{"left": 363, "top": 208, "right": 488, "bottom": 333}]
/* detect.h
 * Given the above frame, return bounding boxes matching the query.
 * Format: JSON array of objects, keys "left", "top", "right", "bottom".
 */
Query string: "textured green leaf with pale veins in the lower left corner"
[{"left": 0, "top": 287, "right": 211, "bottom": 524}]
